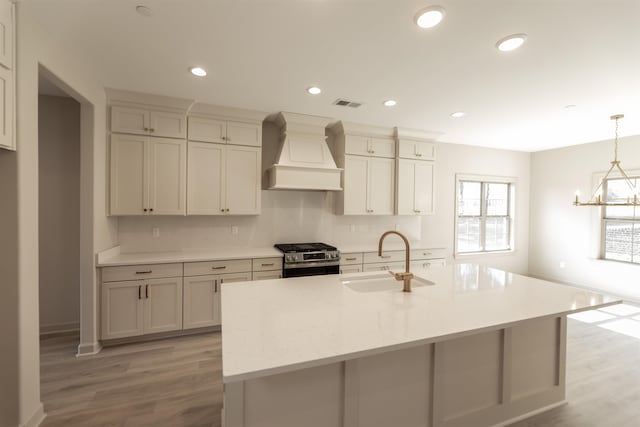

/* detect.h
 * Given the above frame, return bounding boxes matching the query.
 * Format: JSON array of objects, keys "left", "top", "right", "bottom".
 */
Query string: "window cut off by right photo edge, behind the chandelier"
[{"left": 602, "top": 178, "right": 640, "bottom": 264}]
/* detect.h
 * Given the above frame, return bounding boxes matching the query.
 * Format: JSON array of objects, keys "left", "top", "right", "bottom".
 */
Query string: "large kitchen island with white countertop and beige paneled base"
[{"left": 222, "top": 264, "right": 622, "bottom": 427}]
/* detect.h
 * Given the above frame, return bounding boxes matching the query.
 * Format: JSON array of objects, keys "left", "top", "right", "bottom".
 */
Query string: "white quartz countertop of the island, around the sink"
[{"left": 222, "top": 264, "right": 622, "bottom": 383}]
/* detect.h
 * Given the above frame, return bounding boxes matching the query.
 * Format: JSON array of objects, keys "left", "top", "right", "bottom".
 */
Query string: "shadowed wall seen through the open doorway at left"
[{"left": 38, "top": 96, "right": 80, "bottom": 333}]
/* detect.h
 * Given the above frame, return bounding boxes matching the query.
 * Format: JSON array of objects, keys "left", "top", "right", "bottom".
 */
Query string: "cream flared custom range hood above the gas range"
[{"left": 268, "top": 112, "right": 342, "bottom": 191}]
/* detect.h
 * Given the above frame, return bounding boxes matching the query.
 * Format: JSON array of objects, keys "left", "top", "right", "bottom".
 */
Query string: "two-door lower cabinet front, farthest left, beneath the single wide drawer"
[{"left": 101, "top": 277, "right": 182, "bottom": 340}]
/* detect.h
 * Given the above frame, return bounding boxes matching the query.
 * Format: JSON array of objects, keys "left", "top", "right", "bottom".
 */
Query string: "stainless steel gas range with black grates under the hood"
[{"left": 274, "top": 243, "right": 340, "bottom": 277}]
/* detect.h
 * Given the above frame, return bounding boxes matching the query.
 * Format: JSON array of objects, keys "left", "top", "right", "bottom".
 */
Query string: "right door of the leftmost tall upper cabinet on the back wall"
[{"left": 148, "top": 138, "right": 187, "bottom": 215}]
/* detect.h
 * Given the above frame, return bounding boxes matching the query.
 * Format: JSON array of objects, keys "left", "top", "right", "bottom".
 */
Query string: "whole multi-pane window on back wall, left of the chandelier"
[{"left": 455, "top": 177, "right": 515, "bottom": 254}]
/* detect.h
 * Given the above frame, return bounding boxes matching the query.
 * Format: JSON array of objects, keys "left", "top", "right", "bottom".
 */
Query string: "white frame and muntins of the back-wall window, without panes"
[{"left": 453, "top": 174, "right": 517, "bottom": 258}]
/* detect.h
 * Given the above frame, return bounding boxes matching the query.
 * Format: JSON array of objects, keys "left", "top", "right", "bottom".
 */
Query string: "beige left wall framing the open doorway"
[{"left": 0, "top": 2, "right": 116, "bottom": 425}]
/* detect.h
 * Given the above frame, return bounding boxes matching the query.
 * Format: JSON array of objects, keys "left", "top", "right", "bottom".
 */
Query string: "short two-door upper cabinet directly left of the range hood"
[{"left": 188, "top": 116, "right": 262, "bottom": 147}]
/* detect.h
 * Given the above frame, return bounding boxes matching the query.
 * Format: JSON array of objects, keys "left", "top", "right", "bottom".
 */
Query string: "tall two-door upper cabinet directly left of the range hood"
[{"left": 187, "top": 141, "right": 262, "bottom": 215}]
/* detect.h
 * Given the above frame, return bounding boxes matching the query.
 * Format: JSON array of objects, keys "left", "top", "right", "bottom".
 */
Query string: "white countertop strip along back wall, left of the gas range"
[{"left": 97, "top": 248, "right": 282, "bottom": 267}]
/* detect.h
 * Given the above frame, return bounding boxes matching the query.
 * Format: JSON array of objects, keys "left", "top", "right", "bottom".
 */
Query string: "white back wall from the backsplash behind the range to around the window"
[{"left": 118, "top": 130, "right": 529, "bottom": 273}]
